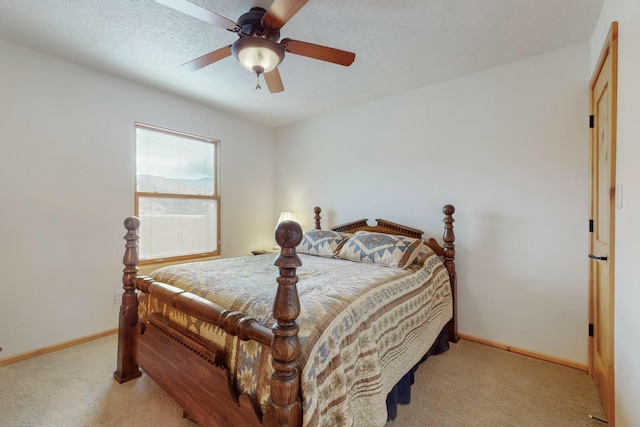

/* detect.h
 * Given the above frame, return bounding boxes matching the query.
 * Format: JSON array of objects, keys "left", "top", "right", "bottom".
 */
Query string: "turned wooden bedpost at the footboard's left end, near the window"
[{"left": 113, "top": 216, "right": 142, "bottom": 383}]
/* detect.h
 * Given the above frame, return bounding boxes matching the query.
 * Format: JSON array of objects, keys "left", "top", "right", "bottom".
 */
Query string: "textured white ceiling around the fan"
[{"left": 0, "top": 0, "right": 603, "bottom": 127}]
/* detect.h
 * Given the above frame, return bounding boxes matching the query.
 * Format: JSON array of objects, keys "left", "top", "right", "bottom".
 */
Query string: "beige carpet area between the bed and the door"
[{"left": 387, "top": 340, "right": 606, "bottom": 427}]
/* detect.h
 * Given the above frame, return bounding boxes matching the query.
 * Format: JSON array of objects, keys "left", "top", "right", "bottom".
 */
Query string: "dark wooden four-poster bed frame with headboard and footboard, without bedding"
[{"left": 114, "top": 205, "right": 459, "bottom": 427}]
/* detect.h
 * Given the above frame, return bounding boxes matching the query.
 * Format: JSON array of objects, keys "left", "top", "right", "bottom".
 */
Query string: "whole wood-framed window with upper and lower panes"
[{"left": 135, "top": 123, "right": 220, "bottom": 263}]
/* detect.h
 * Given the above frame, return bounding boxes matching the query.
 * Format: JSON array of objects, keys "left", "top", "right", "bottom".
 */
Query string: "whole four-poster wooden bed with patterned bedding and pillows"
[{"left": 114, "top": 205, "right": 459, "bottom": 427}]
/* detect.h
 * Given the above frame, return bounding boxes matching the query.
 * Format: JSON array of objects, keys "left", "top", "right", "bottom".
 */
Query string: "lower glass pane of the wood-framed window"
[{"left": 138, "top": 197, "right": 218, "bottom": 259}]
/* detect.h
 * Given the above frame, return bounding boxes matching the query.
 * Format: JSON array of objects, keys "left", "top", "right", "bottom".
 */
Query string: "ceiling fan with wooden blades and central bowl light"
[{"left": 156, "top": 0, "right": 356, "bottom": 93}]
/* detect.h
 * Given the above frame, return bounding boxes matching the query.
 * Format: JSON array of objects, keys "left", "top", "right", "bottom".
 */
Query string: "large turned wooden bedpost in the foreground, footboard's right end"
[{"left": 263, "top": 221, "right": 302, "bottom": 427}]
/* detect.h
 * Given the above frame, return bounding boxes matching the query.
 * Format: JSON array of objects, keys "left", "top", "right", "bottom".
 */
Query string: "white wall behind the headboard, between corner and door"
[{"left": 275, "top": 43, "right": 589, "bottom": 365}]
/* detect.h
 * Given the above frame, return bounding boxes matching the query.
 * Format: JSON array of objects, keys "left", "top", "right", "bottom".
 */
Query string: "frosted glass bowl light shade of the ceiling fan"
[{"left": 231, "top": 37, "right": 284, "bottom": 74}]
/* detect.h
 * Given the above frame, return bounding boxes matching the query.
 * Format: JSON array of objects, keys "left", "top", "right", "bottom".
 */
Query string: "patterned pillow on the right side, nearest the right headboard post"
[{"left": 338, "top": 231, "right": 423, "bottom": 268}]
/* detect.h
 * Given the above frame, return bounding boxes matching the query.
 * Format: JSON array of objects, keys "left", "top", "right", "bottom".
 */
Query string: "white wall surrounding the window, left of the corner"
[{"left": 0, "top": 40, "right": 276, "bottom": 363}]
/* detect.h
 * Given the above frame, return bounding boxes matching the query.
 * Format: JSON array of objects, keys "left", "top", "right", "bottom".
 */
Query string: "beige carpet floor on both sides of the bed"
[{"left": 0, "top": 335, "right": 604, "bottom": 427}]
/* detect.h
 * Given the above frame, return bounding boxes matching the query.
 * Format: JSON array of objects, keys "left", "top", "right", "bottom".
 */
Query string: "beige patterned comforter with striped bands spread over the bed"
[{"left": 140, "top": 247, "right": 452, "bottom": 427}]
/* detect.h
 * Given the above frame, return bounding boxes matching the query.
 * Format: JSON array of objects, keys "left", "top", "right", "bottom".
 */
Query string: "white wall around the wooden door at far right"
[{"left": 591, "top": 0, "right": 640, "bottom": 426}]
